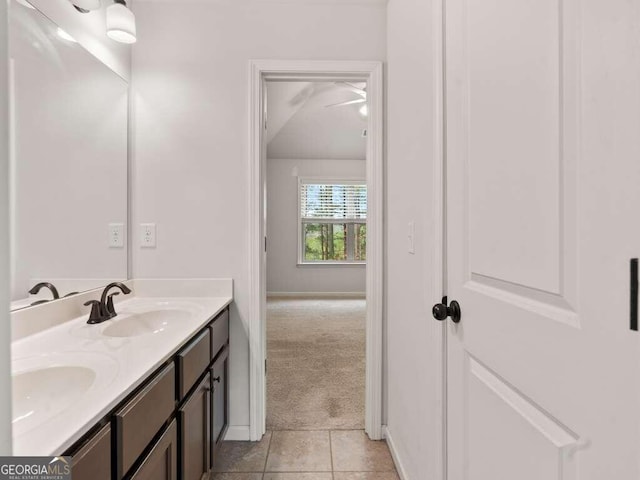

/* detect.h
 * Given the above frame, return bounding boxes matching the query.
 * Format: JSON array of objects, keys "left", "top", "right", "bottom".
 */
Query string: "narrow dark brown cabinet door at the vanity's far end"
[{"left": 211, "top": 348, "right": 229, "bottom": 466}]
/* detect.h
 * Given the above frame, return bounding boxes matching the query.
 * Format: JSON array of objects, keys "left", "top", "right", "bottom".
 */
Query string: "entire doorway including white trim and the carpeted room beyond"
[{"left": 249, "top": 61, "right": 383, "bottom": 440}]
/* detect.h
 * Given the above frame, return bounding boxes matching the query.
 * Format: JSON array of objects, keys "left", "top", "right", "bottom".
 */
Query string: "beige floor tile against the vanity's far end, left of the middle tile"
[{"left": 214, "top": 432, "right": 271, "bottom": 472}]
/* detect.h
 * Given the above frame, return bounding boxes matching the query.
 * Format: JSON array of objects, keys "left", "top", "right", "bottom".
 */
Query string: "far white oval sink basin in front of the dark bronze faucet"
[{"left": 102, "top": 309, "right": 192, "bottom": 337}]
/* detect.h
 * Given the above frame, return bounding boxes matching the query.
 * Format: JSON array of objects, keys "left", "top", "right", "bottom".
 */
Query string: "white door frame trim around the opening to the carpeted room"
[{"left": 248, "top": 60, "right": 384, "bottom": 441}]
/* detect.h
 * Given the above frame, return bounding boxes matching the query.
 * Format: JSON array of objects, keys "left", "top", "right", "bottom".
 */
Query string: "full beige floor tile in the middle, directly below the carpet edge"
[{"left": 266, "top": 431, "right": 331, "bottom": 472}]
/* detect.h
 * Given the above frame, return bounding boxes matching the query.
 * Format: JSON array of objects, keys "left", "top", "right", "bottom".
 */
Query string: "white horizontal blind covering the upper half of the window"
[{"left": 300, "top": 180, "right": 367, "bottom": 221}]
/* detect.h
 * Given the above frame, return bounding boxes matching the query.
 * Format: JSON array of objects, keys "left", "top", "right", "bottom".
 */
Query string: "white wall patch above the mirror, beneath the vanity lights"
[{"left": 24, "top": 0, "right": 133, "bottom": 80}]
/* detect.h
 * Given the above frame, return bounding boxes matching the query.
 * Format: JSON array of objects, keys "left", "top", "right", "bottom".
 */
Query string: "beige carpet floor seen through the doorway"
[{"left": 267, "top": 298, "right": 366, "bottom": 430}]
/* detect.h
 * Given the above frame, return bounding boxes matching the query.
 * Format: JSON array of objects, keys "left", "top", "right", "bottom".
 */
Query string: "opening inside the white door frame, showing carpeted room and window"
[{"left": 265, "top": 80, "right": 368, "bottom": 431}]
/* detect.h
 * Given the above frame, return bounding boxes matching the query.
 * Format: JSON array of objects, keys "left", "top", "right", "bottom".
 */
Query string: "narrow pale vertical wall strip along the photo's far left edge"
[{"left": 0, "top": 2, "right": 11, "bottom": 455}]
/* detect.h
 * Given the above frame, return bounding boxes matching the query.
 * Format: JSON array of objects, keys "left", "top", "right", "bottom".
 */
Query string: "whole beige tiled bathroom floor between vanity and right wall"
[{"left": 213, "top": 430, "right": 399, "bottom": 480}]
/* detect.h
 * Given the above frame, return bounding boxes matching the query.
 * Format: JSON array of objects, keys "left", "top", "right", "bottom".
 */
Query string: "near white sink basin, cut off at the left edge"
[{"left": 12, "top": 366, "right": 96, "bottom": 430}]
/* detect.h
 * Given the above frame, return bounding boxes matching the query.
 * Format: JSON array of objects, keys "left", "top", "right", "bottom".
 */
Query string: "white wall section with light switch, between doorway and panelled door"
[{"left": 386, "top": 0, "right": 442, "bottom": 480}]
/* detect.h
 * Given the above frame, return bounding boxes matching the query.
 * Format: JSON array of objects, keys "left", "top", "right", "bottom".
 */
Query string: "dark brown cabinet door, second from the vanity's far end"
[{"left": 178, "top": 374, "right": 211, "bottom": 480}]
